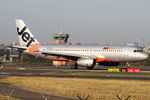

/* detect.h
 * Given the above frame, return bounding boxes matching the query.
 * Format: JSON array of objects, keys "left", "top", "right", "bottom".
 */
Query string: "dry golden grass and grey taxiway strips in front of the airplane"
[{"left": 0, "top": 66, "right": 150, "bottom": 100}]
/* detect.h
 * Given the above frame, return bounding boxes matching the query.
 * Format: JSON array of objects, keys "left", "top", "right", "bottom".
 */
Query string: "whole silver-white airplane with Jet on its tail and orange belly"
[{"left": 13, "top": 20, "right": 149, "bottom": 69}]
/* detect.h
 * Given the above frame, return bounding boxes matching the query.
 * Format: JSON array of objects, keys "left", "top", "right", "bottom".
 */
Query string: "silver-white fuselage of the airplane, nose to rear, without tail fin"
[{"left": 26, "top": 45, "right": 148, "bottom": 62}]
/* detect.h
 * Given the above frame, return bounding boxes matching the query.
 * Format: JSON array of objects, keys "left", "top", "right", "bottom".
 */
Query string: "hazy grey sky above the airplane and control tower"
[{"left": 0, "top": 0, "right": 150, "bottom": 45}]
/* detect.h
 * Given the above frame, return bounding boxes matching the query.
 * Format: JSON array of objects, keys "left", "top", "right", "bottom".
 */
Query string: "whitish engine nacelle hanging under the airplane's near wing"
[{"left": 77, "top": 58, "right": 96, "bottom": 67}]
